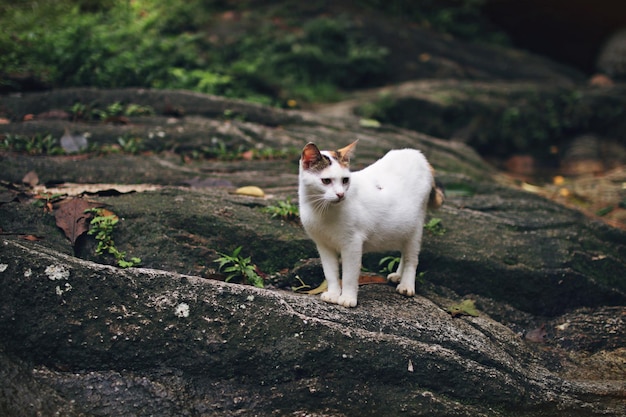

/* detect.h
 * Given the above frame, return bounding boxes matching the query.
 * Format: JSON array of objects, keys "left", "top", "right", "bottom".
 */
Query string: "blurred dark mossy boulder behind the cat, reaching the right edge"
[{"left": 336, "top": 80, "right": 626, "bottom": 167}]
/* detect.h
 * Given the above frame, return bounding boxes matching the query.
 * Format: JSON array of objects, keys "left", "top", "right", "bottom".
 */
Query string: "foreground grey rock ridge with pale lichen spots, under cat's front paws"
[{"left": 0, "top": 239, "right": 624, "bottom": 416}]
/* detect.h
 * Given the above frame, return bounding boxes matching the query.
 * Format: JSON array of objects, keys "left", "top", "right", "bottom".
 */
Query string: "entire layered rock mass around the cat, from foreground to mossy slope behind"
[{"left": 0, "top": 90, "right": 626, "bottom": 416}]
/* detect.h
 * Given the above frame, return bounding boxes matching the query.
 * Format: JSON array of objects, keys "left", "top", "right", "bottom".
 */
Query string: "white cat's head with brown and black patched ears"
[{"left": 300, "top": 141, "right": 356, "bottom": 206}]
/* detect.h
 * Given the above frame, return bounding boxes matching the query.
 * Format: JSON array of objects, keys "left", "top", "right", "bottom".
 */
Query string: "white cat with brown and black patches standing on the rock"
[{"left": 298, "top": 142, "right": 443, "bottom": 307}]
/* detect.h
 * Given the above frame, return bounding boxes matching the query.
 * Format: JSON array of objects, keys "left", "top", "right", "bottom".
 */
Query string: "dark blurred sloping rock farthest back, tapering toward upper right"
[{"left": 336, "top": 5, "right": 583, "bottom": 83}]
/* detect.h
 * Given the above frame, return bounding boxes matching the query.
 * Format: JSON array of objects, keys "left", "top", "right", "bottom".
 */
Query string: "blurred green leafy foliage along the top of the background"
[{"left": 0, "top": 0, "right": 498, "bottom": 105}]
